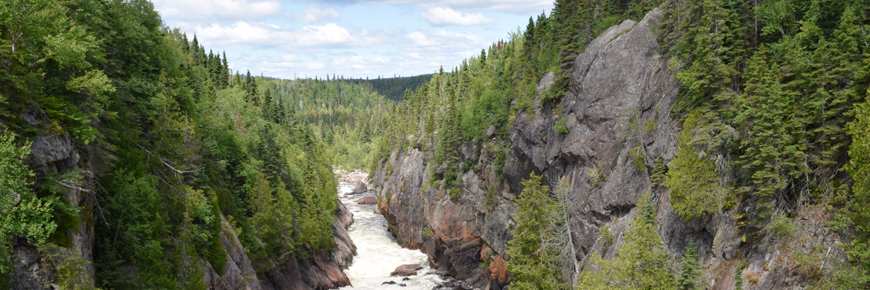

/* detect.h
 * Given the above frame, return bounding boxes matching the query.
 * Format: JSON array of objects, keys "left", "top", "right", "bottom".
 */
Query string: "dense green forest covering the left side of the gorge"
[{"left": 0, "top": 0, "right": 372, "bottom": 289}]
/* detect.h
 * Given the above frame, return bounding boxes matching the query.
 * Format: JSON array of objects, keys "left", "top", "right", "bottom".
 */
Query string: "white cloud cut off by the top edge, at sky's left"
[{"left": 153, "top": 0, "right": 281, "bottom": 20}]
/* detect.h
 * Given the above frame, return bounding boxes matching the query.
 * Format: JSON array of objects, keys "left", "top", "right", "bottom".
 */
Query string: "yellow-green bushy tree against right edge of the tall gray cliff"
[{"left": 665, "top": 110, "right": 723, "bottom": 220}]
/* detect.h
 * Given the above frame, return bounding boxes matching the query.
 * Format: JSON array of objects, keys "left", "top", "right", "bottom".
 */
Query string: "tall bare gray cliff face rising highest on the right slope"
[{"left": 505, "top": 10, "right": 692, "bottom": 268}]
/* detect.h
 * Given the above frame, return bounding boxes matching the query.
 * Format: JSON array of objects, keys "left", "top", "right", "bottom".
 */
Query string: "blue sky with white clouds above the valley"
[{"left": 152, "top": 0, "right": 553, "bottom": 79}]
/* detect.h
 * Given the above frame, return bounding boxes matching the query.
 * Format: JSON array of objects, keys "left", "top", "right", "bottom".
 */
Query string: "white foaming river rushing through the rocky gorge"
[{"left": 338, "top": 182, "right": 444, "bottom": 290}]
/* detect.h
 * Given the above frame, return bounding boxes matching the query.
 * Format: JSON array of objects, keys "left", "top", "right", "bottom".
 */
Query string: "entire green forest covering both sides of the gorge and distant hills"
[{"left": 0, "top": 0, "right": 870, "bottom": 289}]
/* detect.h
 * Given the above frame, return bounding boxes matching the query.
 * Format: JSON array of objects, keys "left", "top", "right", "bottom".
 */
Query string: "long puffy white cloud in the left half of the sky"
[{"left": 194, "top": 21, "right": 380, "bottom": 47}]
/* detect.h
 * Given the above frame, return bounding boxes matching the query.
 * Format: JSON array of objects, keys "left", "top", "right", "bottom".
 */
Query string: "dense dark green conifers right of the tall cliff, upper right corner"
[{"left": 656, "top": 0, "right": 868, "bottom": 222}]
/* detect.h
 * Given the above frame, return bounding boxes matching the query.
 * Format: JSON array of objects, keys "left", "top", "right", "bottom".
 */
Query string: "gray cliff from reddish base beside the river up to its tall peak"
[{"left": 374, "top": 11, "right": 688, "bottom": 289}]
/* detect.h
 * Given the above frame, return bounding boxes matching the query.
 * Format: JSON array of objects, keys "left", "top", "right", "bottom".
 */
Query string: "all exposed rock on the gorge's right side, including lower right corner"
[{"left": 372, "top": 9, "right": 844, "bottom": 289}]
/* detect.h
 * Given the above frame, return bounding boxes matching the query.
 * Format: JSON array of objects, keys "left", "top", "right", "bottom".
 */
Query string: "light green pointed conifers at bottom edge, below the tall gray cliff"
[{"left": 577, "top": 193, "right": 677, "bottom": 289}]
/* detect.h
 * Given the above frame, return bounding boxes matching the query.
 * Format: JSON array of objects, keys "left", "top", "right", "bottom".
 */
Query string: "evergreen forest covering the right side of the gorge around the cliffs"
[{"left": 369, "top": 0, "right": 870, "bottom": 289}]
